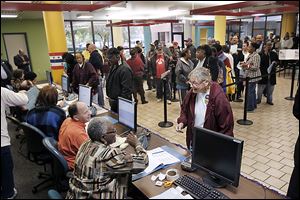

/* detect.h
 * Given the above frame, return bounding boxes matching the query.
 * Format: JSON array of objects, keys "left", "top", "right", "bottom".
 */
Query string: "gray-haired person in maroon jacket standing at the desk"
[{"left": 176, "top": 67, "right": 234, "bottom": 150}]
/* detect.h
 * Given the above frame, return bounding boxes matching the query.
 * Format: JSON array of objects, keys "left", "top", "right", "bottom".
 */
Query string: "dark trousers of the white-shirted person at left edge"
[{"left": 1, "top": 146, "right": 15, "bottom": 199}]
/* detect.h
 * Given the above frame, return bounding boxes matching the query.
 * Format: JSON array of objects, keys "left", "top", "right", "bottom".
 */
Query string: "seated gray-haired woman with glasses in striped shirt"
[{"left": 66, "top": 117, "right": 148, "bottom": 199}]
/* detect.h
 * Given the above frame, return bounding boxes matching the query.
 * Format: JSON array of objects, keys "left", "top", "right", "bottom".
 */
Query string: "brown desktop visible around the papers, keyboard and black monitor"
[{"left": 93, "top": 112, "right": 284, "bottom": 199}]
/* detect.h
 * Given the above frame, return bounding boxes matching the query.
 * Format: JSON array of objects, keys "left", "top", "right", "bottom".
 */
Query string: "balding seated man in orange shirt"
[{"left": 57, "top": 102, "right": 91, "bottom": 170}]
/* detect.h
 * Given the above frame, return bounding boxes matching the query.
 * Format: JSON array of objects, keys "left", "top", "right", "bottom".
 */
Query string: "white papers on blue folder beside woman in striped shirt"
[{"left": 132, "top": 146, "right": 184, "bottom": 181}]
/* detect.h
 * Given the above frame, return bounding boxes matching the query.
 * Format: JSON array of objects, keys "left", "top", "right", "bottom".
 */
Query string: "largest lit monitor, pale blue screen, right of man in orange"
[{"left": 118, "top": 97, "right": 137, "bottom": 131}]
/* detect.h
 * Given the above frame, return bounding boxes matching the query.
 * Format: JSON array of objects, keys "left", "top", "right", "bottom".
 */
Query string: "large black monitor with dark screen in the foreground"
[{"left": 192, "top": 128, "right": 244, "bottom": 187}]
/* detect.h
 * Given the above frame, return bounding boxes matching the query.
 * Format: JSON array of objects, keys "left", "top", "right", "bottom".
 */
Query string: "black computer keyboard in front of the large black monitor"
[{"left": 174, "top": 175, "right": 229, "bottom": 199}]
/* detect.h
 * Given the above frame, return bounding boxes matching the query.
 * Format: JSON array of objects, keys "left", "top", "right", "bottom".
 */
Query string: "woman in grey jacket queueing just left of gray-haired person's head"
[{"left": 175, "top": 49, "right": 194, "bottom": 104}]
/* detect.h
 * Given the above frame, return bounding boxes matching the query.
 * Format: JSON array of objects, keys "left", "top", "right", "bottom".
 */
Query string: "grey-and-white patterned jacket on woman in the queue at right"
[{"left": 245, "top": 52, "right": 261, "bottom": 82}]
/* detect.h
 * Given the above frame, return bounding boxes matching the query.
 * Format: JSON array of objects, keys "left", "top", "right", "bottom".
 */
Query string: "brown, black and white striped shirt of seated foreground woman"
[{"left": 66, "top": 140, "right": 148, "bottom": 199}]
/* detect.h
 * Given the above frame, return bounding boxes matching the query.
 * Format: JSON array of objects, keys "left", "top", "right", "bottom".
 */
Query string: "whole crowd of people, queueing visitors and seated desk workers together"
[{"left": 1, "top": 33, "right": 298, "bottom": 198}]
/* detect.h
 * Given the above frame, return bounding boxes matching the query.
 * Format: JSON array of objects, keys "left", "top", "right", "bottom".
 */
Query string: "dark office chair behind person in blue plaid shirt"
[{"left": 20, "top": 122, "right": 52, "bottom": 193}]
